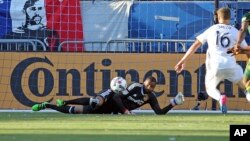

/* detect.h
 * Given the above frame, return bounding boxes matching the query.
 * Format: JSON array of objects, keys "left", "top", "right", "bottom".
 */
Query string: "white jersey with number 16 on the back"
[{"left": 196, "top": 24, "right": 247, "bottom": 69}]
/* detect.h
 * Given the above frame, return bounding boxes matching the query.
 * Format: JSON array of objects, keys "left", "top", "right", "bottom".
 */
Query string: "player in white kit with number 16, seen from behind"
[{"left": 175, "top": 8, "right": 247, "bottom": 114}]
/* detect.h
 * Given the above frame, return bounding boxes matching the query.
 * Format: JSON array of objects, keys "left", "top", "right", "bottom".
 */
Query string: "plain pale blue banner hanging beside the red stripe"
[{"left": 81, "top": 1, "right": 132, "bottom": 51}]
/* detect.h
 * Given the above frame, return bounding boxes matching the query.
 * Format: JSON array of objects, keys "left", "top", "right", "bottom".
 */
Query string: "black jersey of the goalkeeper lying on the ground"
[{"left": 113, "top": 83, "right": 171, "bottom": 114}]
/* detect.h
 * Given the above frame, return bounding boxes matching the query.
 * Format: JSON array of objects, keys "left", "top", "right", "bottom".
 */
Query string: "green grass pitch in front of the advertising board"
[{"left": 0, "top": 112, "right": 250, "bottom": 141}]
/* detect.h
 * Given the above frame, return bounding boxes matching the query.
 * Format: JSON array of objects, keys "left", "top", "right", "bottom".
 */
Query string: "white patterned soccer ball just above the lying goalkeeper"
[{"left": 110, "top": 77, "right": 127, "bottom": 94}]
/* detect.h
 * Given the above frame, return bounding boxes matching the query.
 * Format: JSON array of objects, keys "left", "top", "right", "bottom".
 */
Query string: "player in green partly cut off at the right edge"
[{"left": 228, "top": 12, "right": 250, "bottom": 102}]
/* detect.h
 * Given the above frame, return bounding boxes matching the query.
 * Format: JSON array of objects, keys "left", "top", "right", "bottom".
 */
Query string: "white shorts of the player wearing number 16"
[{"left": 205, "top": 65, "right": 243, "bottom": 88}]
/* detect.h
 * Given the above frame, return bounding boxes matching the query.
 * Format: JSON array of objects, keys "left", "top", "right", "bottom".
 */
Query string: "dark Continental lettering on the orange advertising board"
[{"left": 6, "top": 56, "right": 248, "bottom": 107}]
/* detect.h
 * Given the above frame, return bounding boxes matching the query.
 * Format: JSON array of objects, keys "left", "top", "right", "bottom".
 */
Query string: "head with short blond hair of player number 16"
[{"left": 216, "top": 7, "right": 231, "bottom": 24}]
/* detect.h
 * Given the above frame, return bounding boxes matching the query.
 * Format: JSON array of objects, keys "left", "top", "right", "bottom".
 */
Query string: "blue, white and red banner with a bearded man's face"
[{"left": 0, "top": 0, "right": 84, "bottom": 51}]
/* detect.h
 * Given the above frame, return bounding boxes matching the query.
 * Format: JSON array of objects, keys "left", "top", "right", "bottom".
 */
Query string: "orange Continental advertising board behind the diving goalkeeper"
[{"left": 0, "top": 52, "right": 250, "bottom": 110}]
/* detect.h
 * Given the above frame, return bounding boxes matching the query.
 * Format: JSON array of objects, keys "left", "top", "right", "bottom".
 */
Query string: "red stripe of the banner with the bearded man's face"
[{"left": 45, "top": 0, "right": 84, "bottom": 51}]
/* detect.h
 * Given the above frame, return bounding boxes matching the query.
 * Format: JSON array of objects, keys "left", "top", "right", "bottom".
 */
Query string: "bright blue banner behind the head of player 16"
[{"left": 128, "top": 1, "right": 250, "bottom": 52}]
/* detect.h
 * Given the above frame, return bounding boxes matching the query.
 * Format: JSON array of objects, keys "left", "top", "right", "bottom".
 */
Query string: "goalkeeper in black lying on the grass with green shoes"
[{"left": 32, "top": 77, "right": 184, "bottom": 114}]
